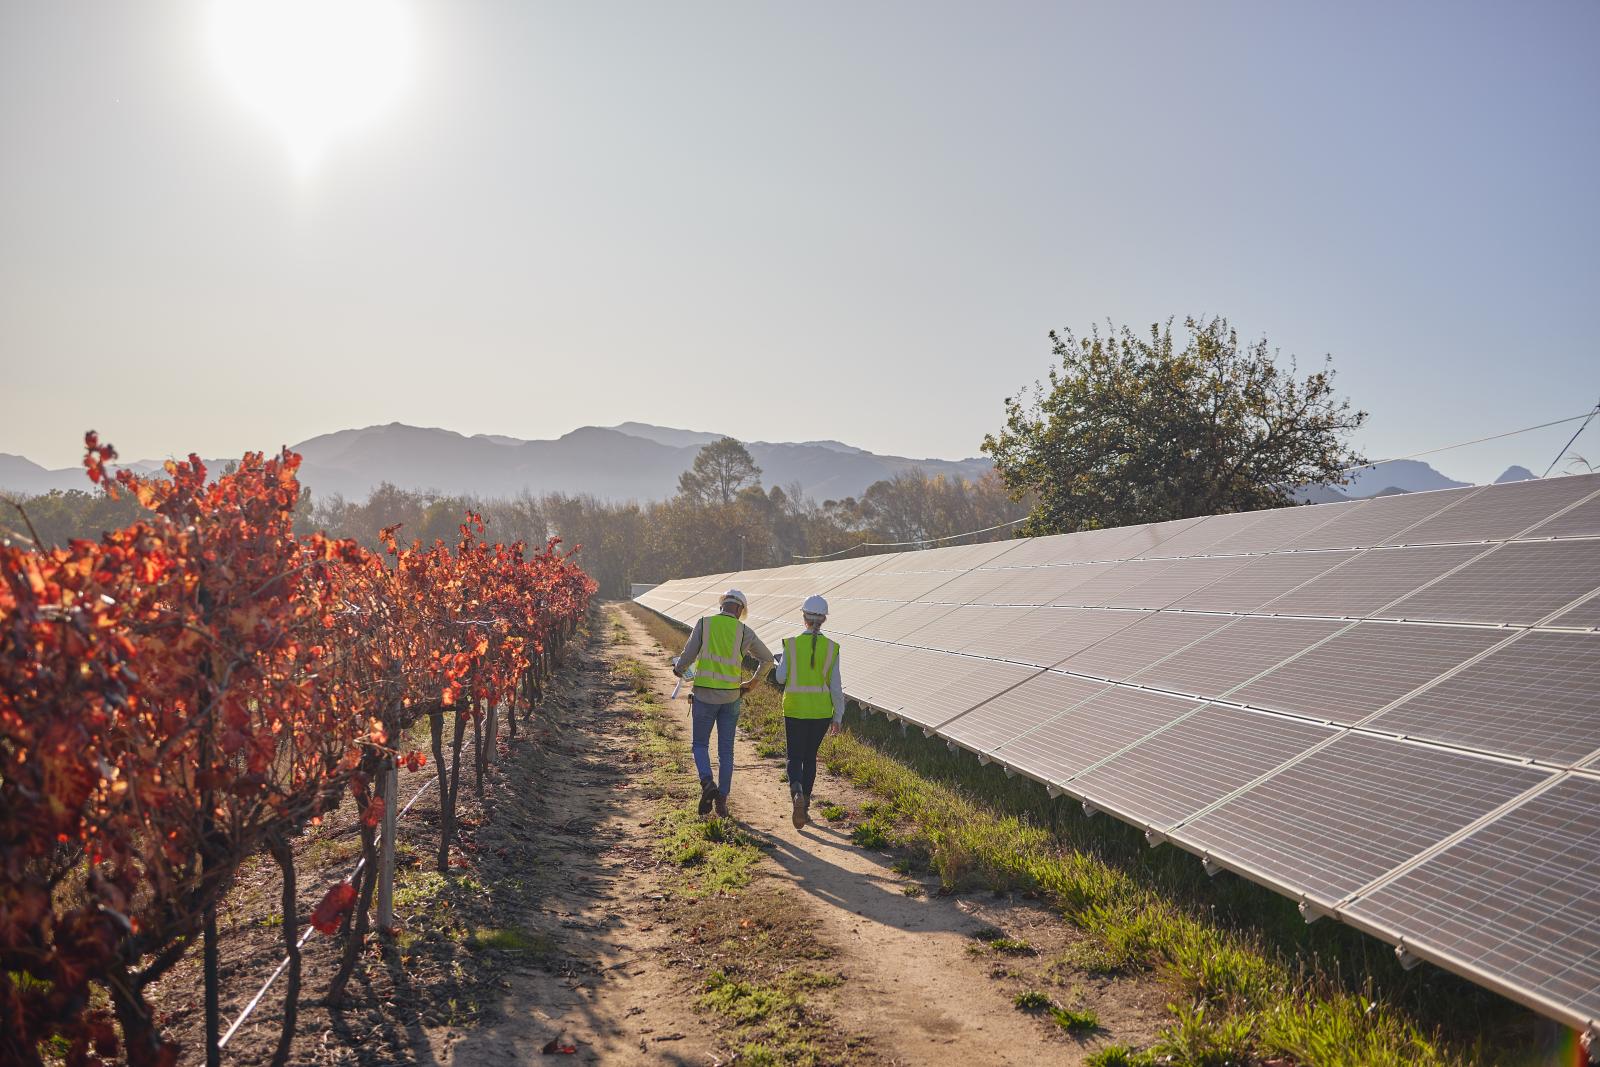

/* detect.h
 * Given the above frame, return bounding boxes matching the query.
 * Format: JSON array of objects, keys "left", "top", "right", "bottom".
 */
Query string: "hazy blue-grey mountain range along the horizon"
[{"left": 0, "top": 422, "right": 1533, "bottom": 502}]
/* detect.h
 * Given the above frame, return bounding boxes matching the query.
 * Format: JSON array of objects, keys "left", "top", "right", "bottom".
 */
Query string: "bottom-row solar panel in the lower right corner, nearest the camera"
[{"left": 1344, "top": 776, "right": 1600, "bottom": 1027}]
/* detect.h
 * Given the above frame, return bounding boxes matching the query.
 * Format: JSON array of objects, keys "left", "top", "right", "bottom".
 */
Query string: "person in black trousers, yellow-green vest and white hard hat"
[{"left": 776, "top": 597, "right": 845, "bottom": 830}]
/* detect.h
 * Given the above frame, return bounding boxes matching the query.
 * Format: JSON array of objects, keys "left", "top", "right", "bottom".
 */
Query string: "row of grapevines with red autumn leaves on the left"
[{"left": 0, "top": 432, "right": 595, "bottom": 1065}]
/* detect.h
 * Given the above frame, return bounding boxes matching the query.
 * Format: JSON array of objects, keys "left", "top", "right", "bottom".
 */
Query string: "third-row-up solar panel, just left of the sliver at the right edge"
[{"left": 1382, "top": 541, "right": 1600, "bottom": 625}]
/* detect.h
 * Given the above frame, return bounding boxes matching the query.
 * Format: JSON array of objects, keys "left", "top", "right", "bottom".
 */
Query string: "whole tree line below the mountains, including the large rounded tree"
[{"left": 0, "top": 318, "right": 1366, "bottom": 597}]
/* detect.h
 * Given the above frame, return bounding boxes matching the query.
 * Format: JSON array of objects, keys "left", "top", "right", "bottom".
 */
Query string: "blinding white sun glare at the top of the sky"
[{"left": 208, "top": 0, "right": 413, "bottom": 176}]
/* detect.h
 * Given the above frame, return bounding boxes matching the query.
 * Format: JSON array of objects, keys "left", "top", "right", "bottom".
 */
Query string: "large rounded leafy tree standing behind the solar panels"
[{"left": 982, "top": 318, "right": 1366, "bottom": 534}]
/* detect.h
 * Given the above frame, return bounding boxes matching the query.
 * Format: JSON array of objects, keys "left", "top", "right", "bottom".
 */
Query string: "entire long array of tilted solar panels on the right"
[{"left": 638, "top": 475, "right": 1600, "bottom": 1029}]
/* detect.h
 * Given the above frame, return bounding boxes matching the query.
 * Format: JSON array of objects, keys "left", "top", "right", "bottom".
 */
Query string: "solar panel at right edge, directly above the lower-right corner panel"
[{"left": 1368, "top": 630, "right": 1600, "bottom": 765}]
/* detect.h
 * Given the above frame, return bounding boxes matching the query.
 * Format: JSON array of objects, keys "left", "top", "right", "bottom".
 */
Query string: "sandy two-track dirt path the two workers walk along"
[{"left": 450, "top": 611, "right": 1152, "bottom": 1064}]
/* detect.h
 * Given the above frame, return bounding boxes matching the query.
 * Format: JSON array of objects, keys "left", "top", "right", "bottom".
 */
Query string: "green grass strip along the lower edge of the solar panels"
[{"left": 614, "top": 609, "right": 1549, "bottom": 1067}]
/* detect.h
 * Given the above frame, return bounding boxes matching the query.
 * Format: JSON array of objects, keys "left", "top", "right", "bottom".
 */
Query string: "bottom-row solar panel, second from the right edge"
[{"left": 1174, "top": 734, "right": 1549, "bottom": 905}]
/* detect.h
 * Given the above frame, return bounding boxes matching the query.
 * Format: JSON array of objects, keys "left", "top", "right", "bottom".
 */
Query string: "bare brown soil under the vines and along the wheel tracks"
[{"left": 154, "top": 606, "right": 1168, "bottom": 1065}]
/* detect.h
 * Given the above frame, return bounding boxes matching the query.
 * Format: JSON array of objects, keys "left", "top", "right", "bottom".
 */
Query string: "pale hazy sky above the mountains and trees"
[{"left": 0, "top": 0, "right": 1600, "bottom": 478}]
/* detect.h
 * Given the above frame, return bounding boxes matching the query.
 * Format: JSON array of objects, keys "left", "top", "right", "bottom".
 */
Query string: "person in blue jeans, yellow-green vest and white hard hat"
[{"left": 672, "top": 589, "right": 773, "bottom": 816}]
